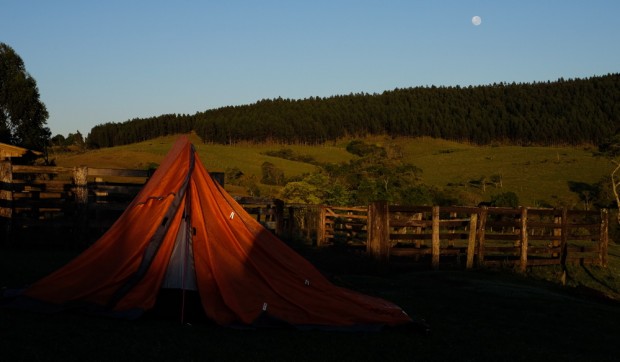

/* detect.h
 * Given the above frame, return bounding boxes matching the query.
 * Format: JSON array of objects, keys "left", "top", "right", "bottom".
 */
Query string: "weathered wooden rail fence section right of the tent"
[{"left": 317, "top": 202, "right": 609, "bottom": 271}]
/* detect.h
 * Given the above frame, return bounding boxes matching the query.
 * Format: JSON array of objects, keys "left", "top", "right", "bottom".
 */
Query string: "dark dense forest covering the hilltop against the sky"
[{"left": 87, "top": 73, "right": 620, "bottom": 148}]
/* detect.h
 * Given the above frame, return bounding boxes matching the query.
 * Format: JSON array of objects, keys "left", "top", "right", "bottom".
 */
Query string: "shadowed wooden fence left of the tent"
[{"left": 0, "top": 161, "right": 224, "bottom": 246}]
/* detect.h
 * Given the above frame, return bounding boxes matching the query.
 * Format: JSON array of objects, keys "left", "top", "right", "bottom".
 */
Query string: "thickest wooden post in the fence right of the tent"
[{"left": 367, "top": 201, "right": 390, "bottom": 266}]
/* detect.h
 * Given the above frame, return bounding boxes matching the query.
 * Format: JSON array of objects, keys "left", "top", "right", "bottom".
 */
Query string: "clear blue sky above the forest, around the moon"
[{"left": 0, "top": 0, "right": 620, "bottom": 136}]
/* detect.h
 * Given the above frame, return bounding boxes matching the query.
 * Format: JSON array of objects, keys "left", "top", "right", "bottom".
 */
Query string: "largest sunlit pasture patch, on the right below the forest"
[{"left": 372, "top": 138, "right": 612, "bottom": 208}]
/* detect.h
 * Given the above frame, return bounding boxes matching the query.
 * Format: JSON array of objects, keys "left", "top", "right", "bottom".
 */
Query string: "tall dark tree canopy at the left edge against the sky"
[{"left": 0, "top": 43, "right": 51, "bottom": 151}]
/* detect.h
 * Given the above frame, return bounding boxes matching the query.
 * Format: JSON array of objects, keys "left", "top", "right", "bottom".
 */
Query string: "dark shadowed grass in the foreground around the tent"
[{"left": 0, "top": 250, "right": 620, "bottom": 361}]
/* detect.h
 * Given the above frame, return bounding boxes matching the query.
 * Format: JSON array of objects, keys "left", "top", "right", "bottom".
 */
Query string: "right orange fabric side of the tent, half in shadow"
[{"left": 189, "top": 151, "right": 410, "bottom": 325}]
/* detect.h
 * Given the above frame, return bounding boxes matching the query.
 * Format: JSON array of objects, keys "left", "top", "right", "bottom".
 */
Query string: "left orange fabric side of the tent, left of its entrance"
[{"left": 23, "top": 140, "right": 191, "bottom": 305}]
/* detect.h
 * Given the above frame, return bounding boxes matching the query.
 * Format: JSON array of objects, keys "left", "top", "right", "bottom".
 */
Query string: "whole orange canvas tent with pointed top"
[{"left": 6, "top": 137, "right": 412, "bottom": 328}]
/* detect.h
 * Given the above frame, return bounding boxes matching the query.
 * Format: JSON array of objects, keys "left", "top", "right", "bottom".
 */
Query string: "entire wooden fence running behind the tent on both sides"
[{"left": 0, "top": 161, "right": 609, "bottom": 270}]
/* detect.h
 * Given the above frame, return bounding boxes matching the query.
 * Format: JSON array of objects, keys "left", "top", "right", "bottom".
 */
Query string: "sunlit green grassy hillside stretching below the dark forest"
[{"left": 51, "top": 135, "right": 611, "bottom": 208}]
